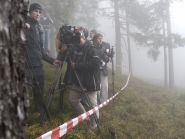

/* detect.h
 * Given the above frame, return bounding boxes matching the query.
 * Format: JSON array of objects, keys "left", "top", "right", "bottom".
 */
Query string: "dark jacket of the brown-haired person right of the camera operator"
[{"left": 94, "top": 42, "right": 110, "bottom": 76}]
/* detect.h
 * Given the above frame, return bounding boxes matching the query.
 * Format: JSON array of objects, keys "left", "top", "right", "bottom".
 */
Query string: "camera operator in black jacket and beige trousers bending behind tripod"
[{"left": 58, "top": 30, "right": 100, "bottom": 129}]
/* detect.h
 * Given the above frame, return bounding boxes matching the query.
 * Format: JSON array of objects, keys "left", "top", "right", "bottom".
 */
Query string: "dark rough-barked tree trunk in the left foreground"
[{"left": 0, "top": 0, "right": 29, "bottom": 139}]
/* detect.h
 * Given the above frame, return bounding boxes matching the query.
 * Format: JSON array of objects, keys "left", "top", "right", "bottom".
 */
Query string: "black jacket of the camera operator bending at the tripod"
[{"left": 59, "top": 41, "right": 100, "bottom": 91}]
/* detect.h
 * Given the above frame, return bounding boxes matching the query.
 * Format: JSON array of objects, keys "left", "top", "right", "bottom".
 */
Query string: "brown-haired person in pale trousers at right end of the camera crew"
[{"left": 93, "top": 33, "right": 110, "bottom": 103}]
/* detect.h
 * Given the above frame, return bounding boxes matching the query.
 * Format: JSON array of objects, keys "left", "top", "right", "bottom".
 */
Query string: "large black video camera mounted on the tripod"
[{"left": 56, "top": 25, "right": 82, "bottom": 52}]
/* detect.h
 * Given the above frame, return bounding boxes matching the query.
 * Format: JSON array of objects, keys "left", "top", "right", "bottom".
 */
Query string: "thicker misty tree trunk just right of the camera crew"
[{"left": 114, "top": 0, "right": 122, "bottom": 73}]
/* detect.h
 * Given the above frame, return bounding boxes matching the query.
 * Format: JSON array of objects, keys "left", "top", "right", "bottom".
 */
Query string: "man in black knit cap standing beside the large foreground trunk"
[{"left": 25, "top": 3, "right": 61, "bottom": 122}]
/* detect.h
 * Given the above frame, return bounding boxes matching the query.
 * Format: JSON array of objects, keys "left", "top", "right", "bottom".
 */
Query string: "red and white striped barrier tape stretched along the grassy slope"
[{"left": 36, "top": 73, "right": 130, "bottom": 139}]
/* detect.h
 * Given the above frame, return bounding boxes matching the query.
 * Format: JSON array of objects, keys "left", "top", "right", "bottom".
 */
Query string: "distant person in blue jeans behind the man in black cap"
[{"left": 39, "top": 11, "right": 53, "bottom": 54}]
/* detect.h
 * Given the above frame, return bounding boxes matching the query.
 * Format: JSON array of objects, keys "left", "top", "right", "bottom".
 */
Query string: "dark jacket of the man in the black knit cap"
[{"left": 25, "top": 16, "right": 54, "bottom": 67}]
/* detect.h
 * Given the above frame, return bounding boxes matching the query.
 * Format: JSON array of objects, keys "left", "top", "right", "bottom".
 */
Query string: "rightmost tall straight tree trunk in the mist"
[{"left": 166, "top": 0, "right": 174, "bottom": 88}]
